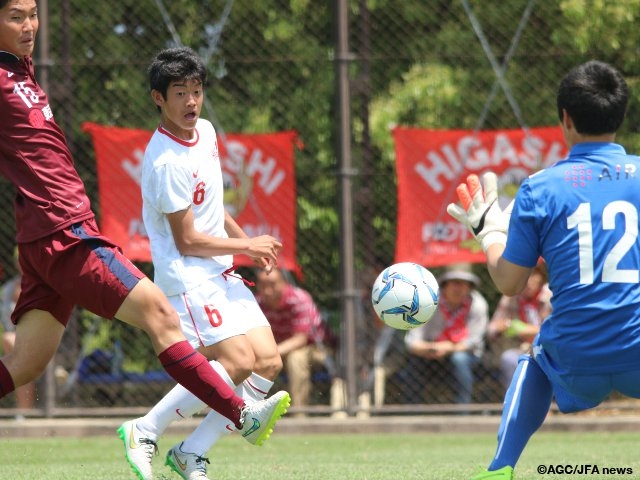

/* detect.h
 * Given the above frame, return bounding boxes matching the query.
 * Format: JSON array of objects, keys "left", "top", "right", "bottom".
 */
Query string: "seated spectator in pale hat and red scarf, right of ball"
[{"left": 400, "top": 264, "right": 489, "bottom": 403}]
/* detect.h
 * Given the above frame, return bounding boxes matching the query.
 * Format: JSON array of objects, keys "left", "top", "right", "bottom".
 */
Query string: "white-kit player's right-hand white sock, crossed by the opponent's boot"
[{"left": 181, "top": 373, "right": 273, "bottom": 456}]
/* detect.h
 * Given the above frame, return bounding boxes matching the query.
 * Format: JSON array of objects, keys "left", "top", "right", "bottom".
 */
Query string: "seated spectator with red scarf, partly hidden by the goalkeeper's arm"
[{"left": 487, "top": 261, "right": 551, "bottom": 391}]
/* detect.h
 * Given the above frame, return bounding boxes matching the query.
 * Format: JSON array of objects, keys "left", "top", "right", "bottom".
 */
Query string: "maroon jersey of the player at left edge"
[{"left": 0, "top": 52, "right": 93, "bottom": 243}]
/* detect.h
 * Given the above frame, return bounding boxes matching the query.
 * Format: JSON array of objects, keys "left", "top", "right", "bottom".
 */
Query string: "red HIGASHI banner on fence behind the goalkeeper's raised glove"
[{"left": 393, "top": 127, "right": 567, "bottom": 267}]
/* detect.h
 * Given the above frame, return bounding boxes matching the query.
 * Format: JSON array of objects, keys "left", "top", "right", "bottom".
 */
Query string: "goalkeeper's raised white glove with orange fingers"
[{"left": 447, "top": 172, "right": 509, "bottom": 252}]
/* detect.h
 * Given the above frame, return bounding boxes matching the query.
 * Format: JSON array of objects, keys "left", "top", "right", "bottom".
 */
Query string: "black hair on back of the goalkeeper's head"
[{"left": 556, "top": 60, "right": 629, "bottom": 135}]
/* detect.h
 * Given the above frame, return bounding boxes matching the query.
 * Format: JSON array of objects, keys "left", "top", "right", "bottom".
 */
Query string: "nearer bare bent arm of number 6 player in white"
[{"left": 167, "top": 207, "right": 282, "bottom": 262}]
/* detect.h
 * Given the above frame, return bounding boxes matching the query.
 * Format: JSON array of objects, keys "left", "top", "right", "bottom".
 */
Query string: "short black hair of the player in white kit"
[{"left": 148, "top": 46, "right": 207, "bottom": 105}]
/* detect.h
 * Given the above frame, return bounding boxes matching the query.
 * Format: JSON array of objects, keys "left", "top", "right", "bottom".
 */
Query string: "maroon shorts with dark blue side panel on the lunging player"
[{"left": 11, "top": 219, "right": 145, "bottom": 326}]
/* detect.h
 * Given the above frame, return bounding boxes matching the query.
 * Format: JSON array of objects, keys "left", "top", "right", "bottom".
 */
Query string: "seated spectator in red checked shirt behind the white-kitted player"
[{"left": 256, "top": 269, "right": 335, "bottom": 414}]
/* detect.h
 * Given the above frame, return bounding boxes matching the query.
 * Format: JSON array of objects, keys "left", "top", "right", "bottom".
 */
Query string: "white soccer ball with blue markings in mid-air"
[{"left": 371, "top": 262, "right": 440, "bottom": 330}]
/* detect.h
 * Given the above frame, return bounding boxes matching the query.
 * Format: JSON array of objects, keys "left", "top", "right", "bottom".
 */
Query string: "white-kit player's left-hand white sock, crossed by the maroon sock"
[{"left": 136, "top": 360, "right": 236, "bottom": 442}]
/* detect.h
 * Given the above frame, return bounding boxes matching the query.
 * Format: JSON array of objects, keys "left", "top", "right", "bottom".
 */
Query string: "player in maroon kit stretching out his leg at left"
[{"left": 0, "top": 0, "right": 288, "bottom": 472}]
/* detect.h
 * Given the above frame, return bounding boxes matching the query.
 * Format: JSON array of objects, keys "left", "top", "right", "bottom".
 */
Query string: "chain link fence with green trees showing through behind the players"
[{"left": 0, "top": 0, "right": 640, "bottom": 412}]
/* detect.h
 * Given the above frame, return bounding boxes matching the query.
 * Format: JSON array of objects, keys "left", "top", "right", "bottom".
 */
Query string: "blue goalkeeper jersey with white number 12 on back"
[{"left": 503, "top": 143, "right": 640, "bottom": 374}]
